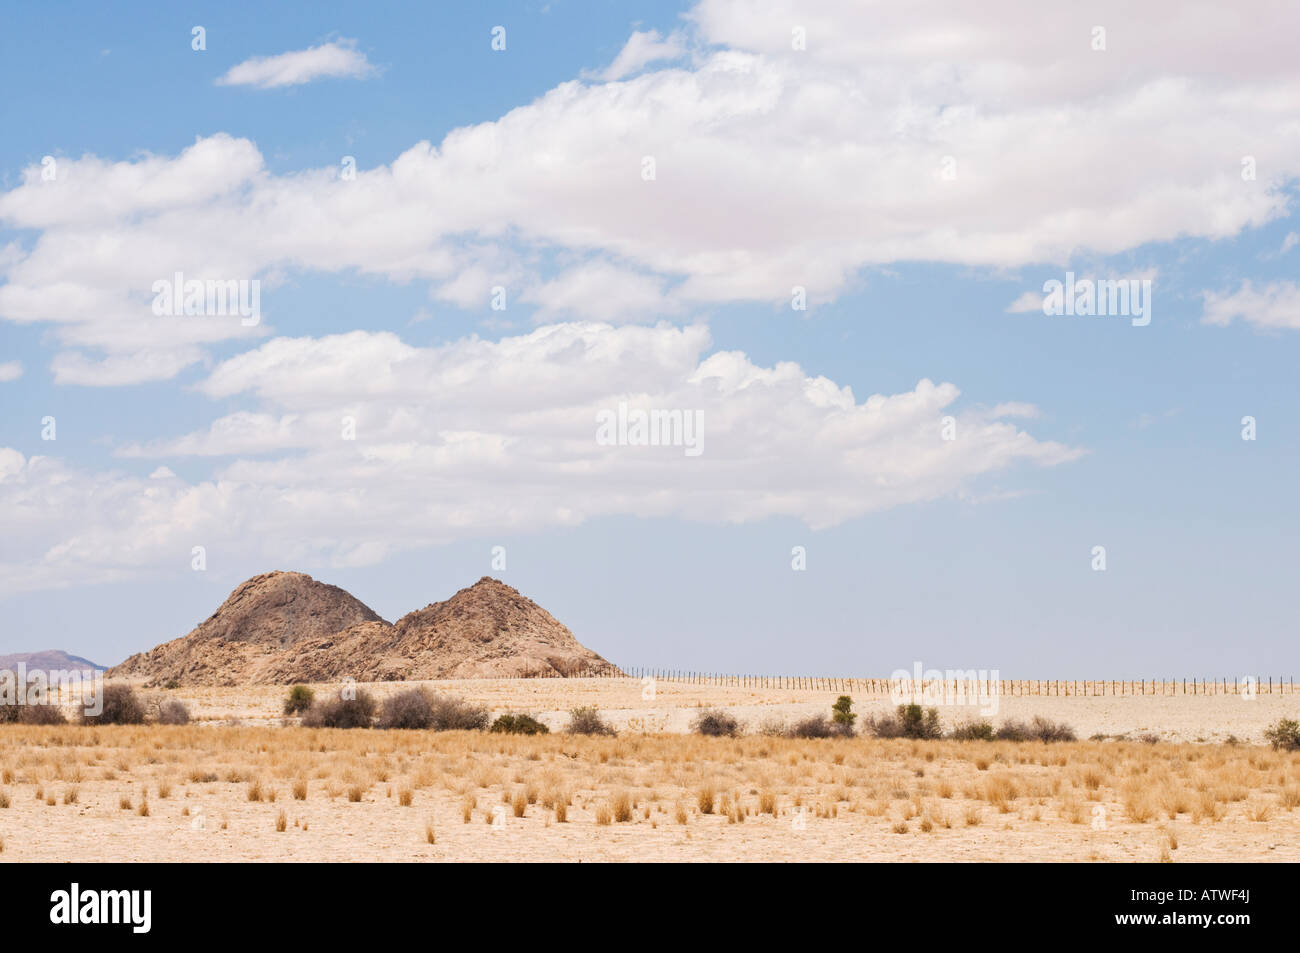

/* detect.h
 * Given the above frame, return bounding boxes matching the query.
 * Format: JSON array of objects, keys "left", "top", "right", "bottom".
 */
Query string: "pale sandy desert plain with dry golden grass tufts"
[{"left": 0, "top": 679, "right": 1300, "bottom": 862}]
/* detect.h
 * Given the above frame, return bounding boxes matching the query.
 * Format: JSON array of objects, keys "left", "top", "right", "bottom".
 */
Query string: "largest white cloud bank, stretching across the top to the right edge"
[{"left": 0, "top": 0, "right": 1300, "bottom": 384}]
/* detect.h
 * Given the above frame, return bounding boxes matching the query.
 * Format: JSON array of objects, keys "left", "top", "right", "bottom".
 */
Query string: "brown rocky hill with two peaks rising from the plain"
[{"left": 108, "top": 572, "right": 618, "bottom": 685}]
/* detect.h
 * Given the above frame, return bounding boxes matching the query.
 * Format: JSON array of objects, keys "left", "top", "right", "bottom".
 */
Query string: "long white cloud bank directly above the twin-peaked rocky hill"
[{"left": 0, "top": 322, "right": 1080, "bottom": 588}]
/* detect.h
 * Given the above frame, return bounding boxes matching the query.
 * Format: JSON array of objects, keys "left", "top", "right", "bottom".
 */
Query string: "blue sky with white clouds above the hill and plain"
[{"left": 0, "top": 0, "right": 1300, "bottom": 679}]
